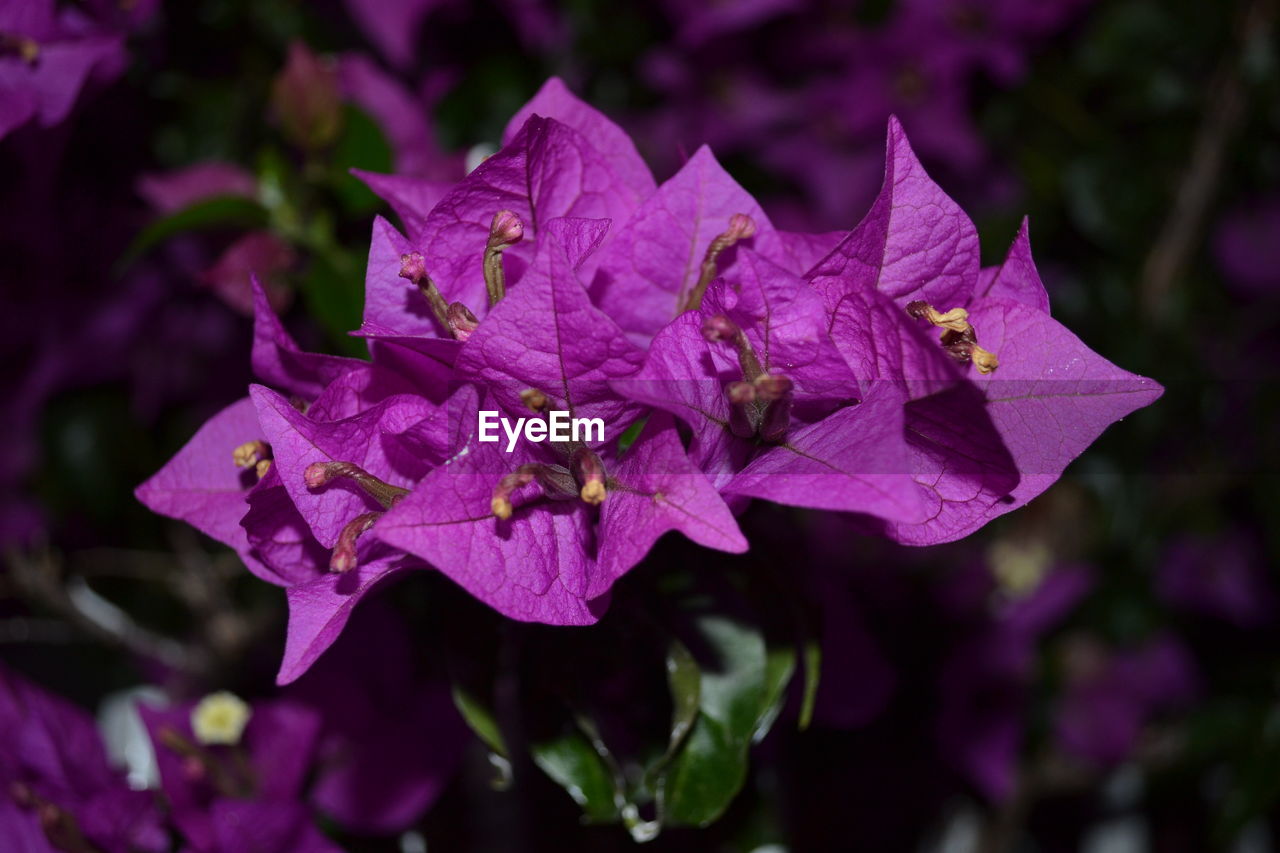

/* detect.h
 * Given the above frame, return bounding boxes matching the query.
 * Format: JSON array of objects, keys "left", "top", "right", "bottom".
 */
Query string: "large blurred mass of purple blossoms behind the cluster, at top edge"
[{"left": 630, "top": 0, "right": 1089, "bottom": 228}]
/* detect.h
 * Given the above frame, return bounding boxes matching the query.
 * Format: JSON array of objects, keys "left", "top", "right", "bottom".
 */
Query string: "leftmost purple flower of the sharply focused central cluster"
[{"left": 137, "top": 282, "right": 445, "bottom": 683}]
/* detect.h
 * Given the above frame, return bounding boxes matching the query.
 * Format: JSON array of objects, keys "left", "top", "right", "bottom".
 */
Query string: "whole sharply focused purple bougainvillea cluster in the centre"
[{"left": 138, "top": 79, "right": 1161, "bottom": 681}]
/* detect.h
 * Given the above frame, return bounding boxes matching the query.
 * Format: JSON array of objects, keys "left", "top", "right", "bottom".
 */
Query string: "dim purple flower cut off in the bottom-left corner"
[{"left": 0, "top": 667, "right": 169, "bottom": 853}]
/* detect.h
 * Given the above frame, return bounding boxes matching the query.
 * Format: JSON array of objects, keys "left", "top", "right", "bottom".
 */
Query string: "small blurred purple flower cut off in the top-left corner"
[{"left": 0, "top": 0, "right": 124, "bottom": 138}]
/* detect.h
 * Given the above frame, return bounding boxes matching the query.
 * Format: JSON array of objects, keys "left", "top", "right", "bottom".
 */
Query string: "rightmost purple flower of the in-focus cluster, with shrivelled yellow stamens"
[{"left": 810, "top": 122, "right": 1162, "bottom": 544}]
